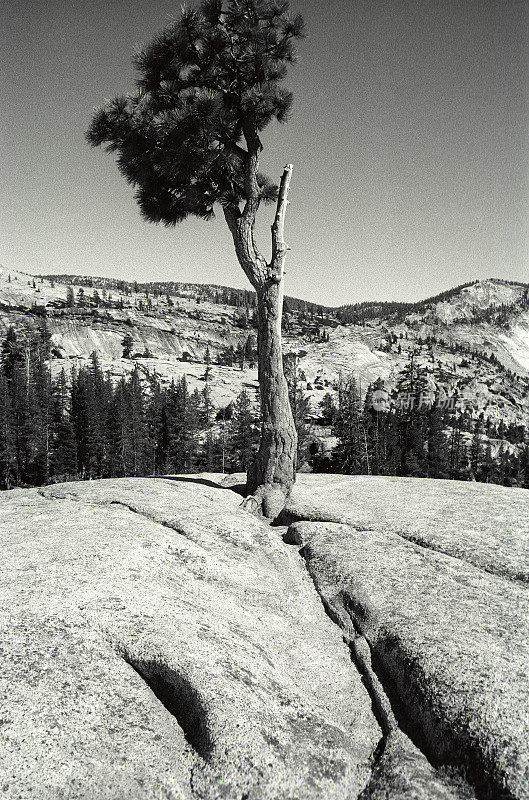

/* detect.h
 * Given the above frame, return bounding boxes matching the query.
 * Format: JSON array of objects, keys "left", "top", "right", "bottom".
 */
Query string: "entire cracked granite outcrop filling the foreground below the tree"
[{"left": 0, "top": 475, "right": 529, "bottom": 800}]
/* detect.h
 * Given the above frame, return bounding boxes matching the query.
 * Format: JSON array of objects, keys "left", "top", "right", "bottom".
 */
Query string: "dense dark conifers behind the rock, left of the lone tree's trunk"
[{"left": 0, "top": 326, "right": 258, "bottom": 489}]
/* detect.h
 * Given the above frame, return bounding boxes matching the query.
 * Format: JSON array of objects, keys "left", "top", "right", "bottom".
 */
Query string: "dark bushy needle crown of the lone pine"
[{"left": 86, "top": 0, "right": 303, "bottom": 226}]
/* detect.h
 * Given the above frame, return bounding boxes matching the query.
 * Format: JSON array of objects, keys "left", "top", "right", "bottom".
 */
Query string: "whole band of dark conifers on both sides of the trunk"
[{"left": 0, "top": 320, "right": 529, "bottom": 489}]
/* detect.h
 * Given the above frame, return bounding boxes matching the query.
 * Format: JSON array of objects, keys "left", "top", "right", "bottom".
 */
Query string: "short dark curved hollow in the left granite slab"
[{"left": 121, "top": 652, "right": 213, "bottom": 761}]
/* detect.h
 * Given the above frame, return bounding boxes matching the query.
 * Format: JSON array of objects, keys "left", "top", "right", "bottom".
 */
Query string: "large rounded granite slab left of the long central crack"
[{"left": 0, "top": 479, "right": 381, "bottom": 800}]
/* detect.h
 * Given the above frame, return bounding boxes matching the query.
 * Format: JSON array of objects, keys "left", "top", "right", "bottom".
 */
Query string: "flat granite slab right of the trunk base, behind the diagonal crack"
[{"left": 282, "top": 475, "right": 529, "bottom": 583}]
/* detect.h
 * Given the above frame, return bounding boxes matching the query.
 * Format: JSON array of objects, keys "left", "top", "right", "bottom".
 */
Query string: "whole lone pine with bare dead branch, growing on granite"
[{"left": 87, "top": 0, "right": 303, "bottom": 517}]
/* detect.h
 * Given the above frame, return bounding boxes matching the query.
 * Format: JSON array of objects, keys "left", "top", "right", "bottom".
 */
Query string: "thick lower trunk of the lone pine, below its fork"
[{"left": 246, "top": 280, "right": 297, "bottom": 517}]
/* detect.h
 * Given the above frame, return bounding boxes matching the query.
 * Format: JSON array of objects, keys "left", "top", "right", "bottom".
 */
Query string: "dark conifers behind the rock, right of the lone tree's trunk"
[{"left": 311, "top": 359, "right": 529, "bottom": 488}]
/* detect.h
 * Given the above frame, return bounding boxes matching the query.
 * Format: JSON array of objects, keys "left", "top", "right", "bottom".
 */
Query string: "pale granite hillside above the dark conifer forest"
[{"left": 0, "top": 270, "right": 529, "bottom": 410}]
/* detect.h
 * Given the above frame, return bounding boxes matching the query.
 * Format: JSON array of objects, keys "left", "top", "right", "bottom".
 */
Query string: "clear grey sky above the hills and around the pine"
[{"left": 0, "top": 0, "right": 529, "bottom": 305}]
